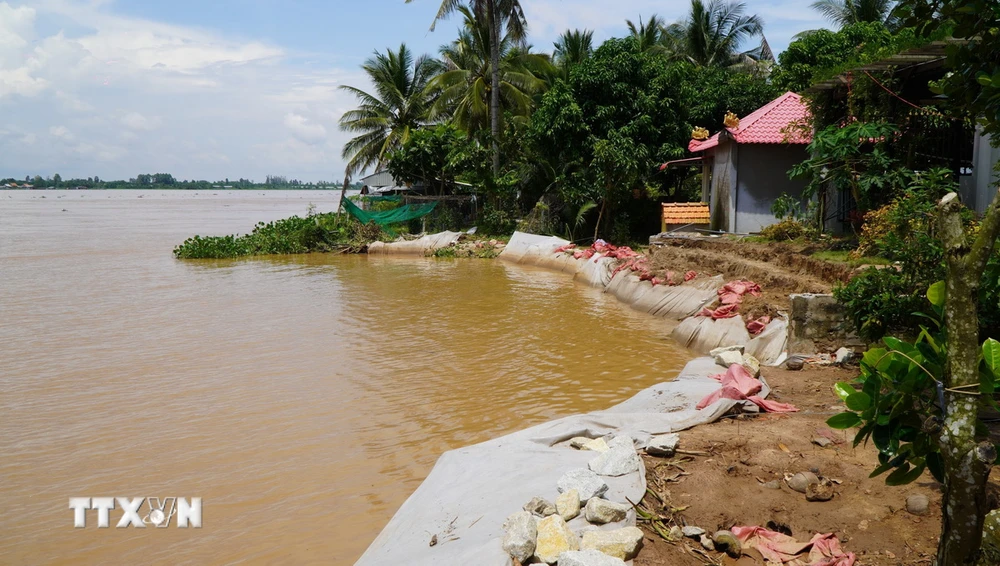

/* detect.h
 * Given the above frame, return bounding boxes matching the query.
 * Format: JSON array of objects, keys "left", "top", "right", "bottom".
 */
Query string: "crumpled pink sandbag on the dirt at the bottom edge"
[{"left": 732, "top": 527, "right": 856, "bottom": 566}]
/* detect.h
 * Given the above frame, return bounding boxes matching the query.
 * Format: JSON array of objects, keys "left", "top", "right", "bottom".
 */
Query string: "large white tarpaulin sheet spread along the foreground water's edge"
[{"left": 357, "top": 358, "right": 768, "bottom": 566}]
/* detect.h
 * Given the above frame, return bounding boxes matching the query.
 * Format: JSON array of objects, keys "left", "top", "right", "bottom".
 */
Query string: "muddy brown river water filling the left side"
[{"left": 0, "top": 191, "right": 689, "bottom": 564}]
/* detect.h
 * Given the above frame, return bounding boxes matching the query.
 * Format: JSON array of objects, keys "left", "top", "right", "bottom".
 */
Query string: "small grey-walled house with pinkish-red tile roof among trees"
[{"left": 664, "top": 92, "right": 812, "bottom": 233}]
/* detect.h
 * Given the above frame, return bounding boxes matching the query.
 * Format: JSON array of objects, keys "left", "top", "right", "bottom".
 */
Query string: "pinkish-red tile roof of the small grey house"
[{"left": 688, "top": 92, "right": 812, "bottom": 151}]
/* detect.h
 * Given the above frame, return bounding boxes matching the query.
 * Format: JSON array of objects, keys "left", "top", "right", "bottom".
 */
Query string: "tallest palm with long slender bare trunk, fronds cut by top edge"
[{"left": 406, "top": 0, "right": 528, "bottom": 175}]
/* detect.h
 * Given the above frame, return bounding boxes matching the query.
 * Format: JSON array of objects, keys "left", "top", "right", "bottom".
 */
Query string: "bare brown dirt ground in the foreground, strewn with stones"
[{"left": 635, "top": 366, "right": 1000, "bottom": 566}]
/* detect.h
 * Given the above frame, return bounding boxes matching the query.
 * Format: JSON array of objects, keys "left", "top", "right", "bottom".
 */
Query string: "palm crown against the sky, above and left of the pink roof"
[{"left": 664, "top": 0, "right": 764, "bottom": 67}]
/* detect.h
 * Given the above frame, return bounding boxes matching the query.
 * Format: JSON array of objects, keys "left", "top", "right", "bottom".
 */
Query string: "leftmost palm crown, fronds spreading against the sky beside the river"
[{"left": 340, "top": 43, "right": 441, "bottom": 177}]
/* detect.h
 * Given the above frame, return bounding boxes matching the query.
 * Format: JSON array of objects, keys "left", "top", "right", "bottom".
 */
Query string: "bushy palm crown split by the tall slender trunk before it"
[{"left": 427, "top": 6, "right": 554, "bottom": 135}]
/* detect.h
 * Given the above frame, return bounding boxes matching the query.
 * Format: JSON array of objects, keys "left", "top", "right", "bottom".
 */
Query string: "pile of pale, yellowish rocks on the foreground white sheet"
[{"left": 503, "top": 436, "right": 642, "bottom": 566}]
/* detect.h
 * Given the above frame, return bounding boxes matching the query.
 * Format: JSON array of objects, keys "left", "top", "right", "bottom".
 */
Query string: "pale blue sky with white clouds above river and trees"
[{"left": 0, "top": 0, "right": 825, "bottom": 181}]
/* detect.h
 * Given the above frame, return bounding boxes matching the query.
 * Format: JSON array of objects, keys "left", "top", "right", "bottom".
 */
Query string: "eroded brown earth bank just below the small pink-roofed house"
[{"left": 650, "top": 237, "right": 853, "bottom": 317}]
